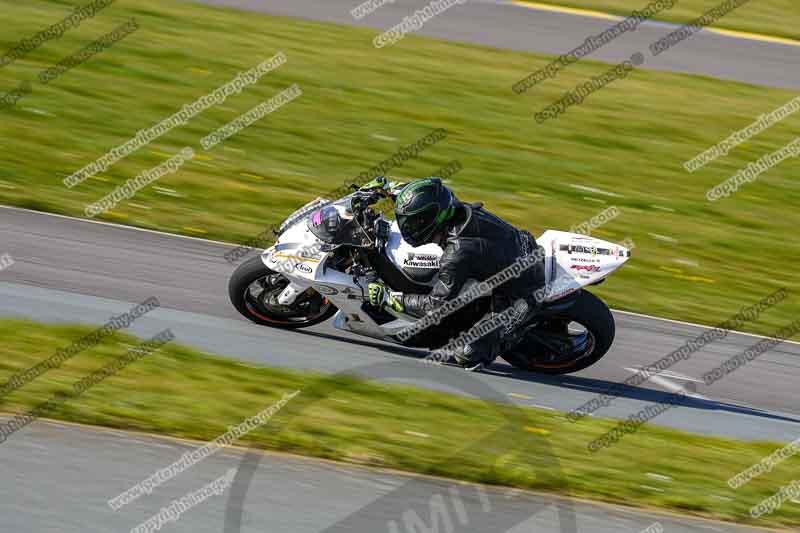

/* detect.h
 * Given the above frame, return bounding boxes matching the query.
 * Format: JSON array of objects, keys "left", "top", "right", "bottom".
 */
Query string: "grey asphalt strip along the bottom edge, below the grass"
[{"left": 0, "top": 422, "right": 762, "bottom": 533}]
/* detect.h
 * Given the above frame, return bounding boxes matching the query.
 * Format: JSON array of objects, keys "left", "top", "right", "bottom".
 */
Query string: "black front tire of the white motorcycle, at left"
[{"left": 228, "top": 256, "right": 336, "bottom": 329}]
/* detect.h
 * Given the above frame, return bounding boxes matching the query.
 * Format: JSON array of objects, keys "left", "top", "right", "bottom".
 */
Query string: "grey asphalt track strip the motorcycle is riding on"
[{"left": 0, "top": 208, "right": 800, "bottom": 441}]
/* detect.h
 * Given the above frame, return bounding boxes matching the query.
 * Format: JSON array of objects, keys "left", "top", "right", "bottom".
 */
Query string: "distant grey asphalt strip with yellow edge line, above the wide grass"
[{"left": 192, "top": 0, "right": 800, "bottom": 89}]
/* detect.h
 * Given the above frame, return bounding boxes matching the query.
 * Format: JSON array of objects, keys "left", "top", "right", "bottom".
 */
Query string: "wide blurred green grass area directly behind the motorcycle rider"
[{"left": 0, "top": 0, "right": 800, "bottom": 334}]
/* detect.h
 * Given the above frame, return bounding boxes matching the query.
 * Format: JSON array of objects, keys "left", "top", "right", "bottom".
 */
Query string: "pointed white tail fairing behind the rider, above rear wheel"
[{"left": 536, "top": 230, "right": 630, "bottom": 302}]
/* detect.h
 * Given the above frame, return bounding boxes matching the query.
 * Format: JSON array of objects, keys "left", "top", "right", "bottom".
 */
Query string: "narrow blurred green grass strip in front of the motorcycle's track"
[{"left": 0, "top": 320, "right": 800, "bottom": 526}]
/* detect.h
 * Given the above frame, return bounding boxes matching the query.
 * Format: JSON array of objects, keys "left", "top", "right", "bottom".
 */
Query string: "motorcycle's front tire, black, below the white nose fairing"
[{"left": 228, "top": 256, "right": 336, "bottom": 329}]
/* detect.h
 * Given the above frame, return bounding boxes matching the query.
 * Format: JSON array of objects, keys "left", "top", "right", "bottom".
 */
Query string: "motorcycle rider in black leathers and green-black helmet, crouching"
[{"left": 369, "top": 177, "right": 544, "bottom": 370}]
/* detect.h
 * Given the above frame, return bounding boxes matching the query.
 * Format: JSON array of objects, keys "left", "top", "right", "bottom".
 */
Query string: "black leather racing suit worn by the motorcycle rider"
[{"left": 402, "top": 204, "right": 544, "bottom": 363}]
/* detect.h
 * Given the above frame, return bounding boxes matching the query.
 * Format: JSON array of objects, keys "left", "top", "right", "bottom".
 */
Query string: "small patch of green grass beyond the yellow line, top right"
[{"left": 522, "top": 0, "right": 800, "bottom": 40}]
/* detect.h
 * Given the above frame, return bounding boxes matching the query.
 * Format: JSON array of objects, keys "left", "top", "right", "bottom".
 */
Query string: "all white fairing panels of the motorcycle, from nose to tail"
[{"left": 261, "top": 218, "right": 630, "bottom": 340}]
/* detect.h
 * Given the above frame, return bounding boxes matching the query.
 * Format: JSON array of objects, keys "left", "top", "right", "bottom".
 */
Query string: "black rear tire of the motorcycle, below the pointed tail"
[{"left": 503, "top": 290, "right": 616, "bottom": 374}]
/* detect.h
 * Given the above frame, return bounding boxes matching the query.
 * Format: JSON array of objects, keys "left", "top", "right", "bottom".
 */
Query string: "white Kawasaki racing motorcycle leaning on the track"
[{"left": 228, "top": 178, "right": 631, "bottom": 374}]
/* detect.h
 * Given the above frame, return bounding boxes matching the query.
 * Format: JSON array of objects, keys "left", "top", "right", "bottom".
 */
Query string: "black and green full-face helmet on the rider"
[{"left": 394, "top": 178, "right": 458, "bottom": 246}]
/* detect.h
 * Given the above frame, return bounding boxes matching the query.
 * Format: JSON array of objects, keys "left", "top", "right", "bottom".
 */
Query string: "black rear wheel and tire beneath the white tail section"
[{"left": 503, "top": 290, "right": 616, "bottom": 374}]
